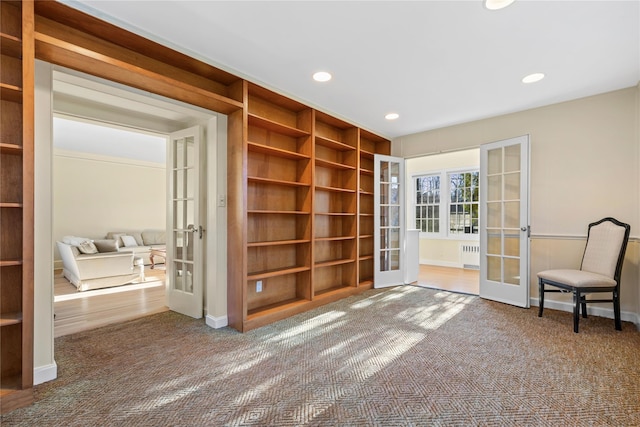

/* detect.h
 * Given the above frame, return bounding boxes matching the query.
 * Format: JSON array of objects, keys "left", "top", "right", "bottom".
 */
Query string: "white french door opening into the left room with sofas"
[{"left": 166, "top": 126, "right": 205, "bottom": 319}]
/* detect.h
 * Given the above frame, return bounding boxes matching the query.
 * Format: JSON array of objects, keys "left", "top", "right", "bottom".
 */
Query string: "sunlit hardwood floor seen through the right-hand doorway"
[{"left": 418, "top": 264, "right": 480, "bottom": 295}]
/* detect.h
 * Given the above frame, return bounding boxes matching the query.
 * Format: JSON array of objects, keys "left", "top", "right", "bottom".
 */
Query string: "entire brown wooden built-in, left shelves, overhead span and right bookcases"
[{"left": 0, "top": 0, "right": 390, "bottom": 356}]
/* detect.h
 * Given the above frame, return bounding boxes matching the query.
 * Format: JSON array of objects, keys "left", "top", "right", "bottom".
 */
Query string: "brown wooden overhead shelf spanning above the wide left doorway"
[{"left": 35, "top": 2, "right": 243, "bottom": 114}]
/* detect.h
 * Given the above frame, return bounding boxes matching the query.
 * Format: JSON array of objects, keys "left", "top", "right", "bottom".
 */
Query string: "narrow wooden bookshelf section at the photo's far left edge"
[{"left": 0, "top": 0, "right": 34, "bottom": 413}]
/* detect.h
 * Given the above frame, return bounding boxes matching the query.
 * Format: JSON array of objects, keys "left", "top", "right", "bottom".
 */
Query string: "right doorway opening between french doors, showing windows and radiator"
[{"left": 406, "top": 149, "right": 480, "bottom": 295}]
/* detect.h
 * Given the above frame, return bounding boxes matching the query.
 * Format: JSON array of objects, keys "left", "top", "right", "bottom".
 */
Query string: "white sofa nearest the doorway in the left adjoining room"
[{"left": 56, "top": 238, "right": 144, "bottom": 291}]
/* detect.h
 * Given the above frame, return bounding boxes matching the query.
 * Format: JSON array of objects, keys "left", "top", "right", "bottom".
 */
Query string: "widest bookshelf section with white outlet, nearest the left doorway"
[{"left": 241, "top": 84, "right": 313, "bottom": 330}]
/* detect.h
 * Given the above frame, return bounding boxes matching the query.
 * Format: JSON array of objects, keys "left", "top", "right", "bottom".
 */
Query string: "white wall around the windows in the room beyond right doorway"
[{"left": 405, "top": 148, "right": 480, "bottom": 268}]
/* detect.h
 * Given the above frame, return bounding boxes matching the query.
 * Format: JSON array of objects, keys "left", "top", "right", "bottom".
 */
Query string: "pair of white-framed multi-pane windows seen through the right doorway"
[{"left": 414, "top": 170, "right": 480, "bottom": 236}]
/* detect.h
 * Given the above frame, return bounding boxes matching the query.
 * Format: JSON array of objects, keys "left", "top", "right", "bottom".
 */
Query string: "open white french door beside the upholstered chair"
[{"left": 480, "top": 135, "right": 529, "bottom": 308}]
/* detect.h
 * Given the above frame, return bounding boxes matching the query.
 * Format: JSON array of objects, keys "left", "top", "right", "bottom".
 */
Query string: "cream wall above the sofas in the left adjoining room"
[{"left": 53, "top": 149, "right": 166, "bottom": 259}]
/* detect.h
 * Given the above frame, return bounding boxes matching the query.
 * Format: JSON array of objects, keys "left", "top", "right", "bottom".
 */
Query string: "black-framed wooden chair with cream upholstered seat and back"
[{"left": 538, "top": 217, "right": 631, "bottom": 333}]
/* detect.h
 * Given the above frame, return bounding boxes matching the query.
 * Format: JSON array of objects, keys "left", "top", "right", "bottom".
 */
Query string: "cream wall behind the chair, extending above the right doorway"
[{"left": 392, "top": 86, "right": 640, "bottom": 322}]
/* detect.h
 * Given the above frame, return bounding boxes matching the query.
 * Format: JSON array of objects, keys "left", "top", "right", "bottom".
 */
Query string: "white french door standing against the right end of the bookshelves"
[{"left": 373, "top": 154, "right": 405, "bottom": 288}]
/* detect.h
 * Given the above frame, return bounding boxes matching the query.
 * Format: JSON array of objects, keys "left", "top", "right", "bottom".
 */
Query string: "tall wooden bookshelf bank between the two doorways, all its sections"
[{"left": 228, "top": 83, "right": 390, "bottom": 331}]
